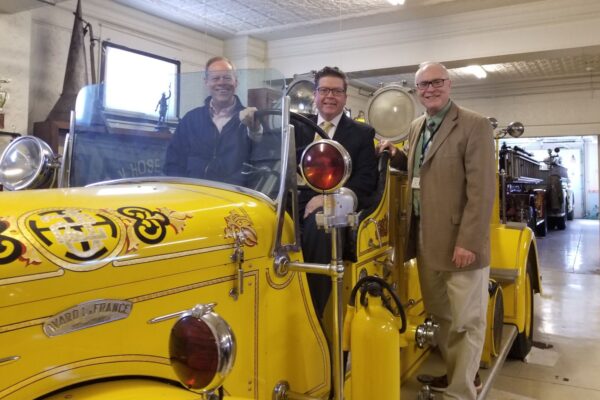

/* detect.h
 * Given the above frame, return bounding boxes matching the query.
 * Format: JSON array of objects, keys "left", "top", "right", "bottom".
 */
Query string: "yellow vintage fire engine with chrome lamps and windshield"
[{"left": 0, "top": 71, "right": 541, "bottom": 400}]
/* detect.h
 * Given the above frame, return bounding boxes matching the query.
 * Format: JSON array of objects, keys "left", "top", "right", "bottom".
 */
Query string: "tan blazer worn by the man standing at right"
[{"left": 405, "top": 103, "right": 496, "bottom": 271}]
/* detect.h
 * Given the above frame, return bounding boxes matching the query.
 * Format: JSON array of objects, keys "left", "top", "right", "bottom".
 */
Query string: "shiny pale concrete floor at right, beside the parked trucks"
[{"left": 487, "top": 219, "right": 600, "bottom": 400}]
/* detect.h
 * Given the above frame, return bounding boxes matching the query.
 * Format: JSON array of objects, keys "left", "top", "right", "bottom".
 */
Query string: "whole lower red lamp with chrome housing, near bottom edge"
[{"left": 169, "top": 304, "right": 235, "bottom": 392}]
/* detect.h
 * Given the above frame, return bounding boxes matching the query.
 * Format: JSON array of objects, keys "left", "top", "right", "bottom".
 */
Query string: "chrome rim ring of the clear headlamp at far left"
[{"left": 0, "top": 135, "right": 55, "bottom": 191}]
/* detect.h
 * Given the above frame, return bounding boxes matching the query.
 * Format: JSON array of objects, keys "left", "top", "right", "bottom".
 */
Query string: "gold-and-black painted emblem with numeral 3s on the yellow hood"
[{"left": 0, "top": 206, "right": 191, "bottom": 271}]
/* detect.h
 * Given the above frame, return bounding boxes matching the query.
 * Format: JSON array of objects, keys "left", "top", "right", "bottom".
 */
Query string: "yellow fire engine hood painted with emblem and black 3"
[{"left": 0, "top": 183, "right": 276, "bottom": 310}]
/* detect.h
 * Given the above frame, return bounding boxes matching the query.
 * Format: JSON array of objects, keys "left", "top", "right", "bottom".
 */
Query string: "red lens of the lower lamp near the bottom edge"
[{"left": 169, "top": 316, "right": 219, "bottom": 390}]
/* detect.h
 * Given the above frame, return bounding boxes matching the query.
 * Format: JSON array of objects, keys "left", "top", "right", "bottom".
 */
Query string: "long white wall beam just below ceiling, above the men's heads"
[{"left": 268, "top": 0, "right": 600, "bottom": 76}]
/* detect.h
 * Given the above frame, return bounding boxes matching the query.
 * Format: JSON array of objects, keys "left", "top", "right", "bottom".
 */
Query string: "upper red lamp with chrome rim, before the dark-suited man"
[{"left": 300, "top": 140, "right": 352, "bottom": 193}]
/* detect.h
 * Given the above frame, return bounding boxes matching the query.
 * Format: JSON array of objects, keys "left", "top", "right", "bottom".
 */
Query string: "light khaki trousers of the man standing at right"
[{"left": 417, "top": 239, "right": 490, "bottom": 400}]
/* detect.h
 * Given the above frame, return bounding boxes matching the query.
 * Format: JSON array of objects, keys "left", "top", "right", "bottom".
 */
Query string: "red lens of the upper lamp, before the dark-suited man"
[{"left": 302, "top": 142, "right": 345, "bottom": 191}]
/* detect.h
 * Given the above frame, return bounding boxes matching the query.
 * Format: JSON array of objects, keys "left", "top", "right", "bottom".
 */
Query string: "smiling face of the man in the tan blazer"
[{"left": 415, "top": 64, "right": 452, "bottom": 116}]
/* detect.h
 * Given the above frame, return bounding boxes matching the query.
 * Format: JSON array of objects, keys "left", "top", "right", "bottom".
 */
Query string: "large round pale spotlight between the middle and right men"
[{"left": 367, "top": 84, "right": 416, "bottom": 143}]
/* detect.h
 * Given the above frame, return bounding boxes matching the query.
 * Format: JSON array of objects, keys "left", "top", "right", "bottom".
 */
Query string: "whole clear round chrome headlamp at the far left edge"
[{"left": 0, "top": 136, "right": 55, "bottom": 190}]
